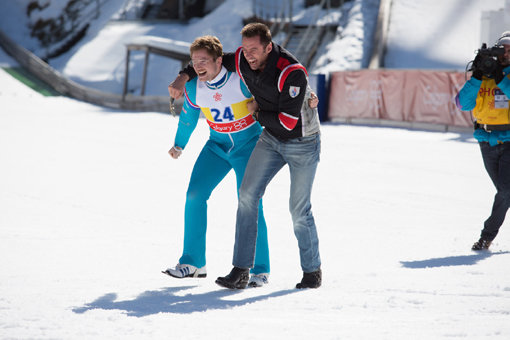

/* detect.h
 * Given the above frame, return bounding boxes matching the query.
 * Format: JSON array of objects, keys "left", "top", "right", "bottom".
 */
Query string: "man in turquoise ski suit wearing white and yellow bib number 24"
[{"left": 164, "top": 36, "right": 270, "bottom": 287}]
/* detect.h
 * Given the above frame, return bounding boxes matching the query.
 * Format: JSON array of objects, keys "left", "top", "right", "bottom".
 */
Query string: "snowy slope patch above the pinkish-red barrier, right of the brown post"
[{"left": 385, "top": 0, "right": 505, "bottom": 71}]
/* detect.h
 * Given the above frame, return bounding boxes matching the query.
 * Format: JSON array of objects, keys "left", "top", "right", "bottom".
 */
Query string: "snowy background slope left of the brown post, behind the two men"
[{"left": 0, "top": 0, "right": 379, "bottom": 95}]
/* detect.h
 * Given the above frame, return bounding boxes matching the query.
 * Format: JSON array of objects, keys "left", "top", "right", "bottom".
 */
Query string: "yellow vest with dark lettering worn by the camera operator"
[{"left": 473, "top": 77, "right": 510, "bottom": 125}]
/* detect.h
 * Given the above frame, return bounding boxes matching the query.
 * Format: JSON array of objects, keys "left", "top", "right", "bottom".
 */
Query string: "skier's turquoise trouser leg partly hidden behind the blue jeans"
[{"left": 231, "top": 136, "right": 271, "bottom": 274}]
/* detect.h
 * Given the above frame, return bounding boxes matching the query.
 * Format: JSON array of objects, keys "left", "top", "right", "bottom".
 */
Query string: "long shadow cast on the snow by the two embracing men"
[{"left": 73, "top": 286, "right": 298, "bottom": 317}]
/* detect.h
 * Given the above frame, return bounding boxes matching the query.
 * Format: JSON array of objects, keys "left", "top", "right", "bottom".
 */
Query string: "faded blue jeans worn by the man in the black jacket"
[{"left": 233, "top": 130, "right": 321, "bottom": 273}]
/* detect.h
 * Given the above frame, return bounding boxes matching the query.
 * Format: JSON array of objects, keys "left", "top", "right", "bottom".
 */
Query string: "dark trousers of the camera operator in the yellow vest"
[{"left": 480, "top": 142, "right": 510, "bottom": 241}]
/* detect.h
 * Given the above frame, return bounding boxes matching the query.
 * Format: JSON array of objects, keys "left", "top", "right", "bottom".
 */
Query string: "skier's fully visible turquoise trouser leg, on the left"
[{"left": 179, "top": 141, "right": 232, "bottom": 268}]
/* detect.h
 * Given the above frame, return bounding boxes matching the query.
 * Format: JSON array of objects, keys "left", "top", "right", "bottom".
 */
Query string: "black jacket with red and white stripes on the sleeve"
[{"left": 184, "top": 43, "right": 308, "bottom": 140}]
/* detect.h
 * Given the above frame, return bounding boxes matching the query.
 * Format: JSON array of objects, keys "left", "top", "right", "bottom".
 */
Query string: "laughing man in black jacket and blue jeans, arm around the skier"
[{"left": 169, "top": 23, "right": 322, "bottom": 289}]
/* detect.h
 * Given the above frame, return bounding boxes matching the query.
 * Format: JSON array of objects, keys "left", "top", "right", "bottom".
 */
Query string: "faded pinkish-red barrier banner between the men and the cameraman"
[{"left": 328, "top": 70, "right": 473, "bottom": 127}]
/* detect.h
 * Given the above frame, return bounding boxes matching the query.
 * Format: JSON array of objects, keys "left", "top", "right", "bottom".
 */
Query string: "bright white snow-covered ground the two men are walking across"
[{"left": 0, "top": 0, "right": 510, "bottom": 340}]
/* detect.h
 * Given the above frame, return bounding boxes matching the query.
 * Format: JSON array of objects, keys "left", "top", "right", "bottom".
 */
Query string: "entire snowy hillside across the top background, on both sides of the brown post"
[{"left": 0, "top": 0, "right": 505, "bottom": 95}]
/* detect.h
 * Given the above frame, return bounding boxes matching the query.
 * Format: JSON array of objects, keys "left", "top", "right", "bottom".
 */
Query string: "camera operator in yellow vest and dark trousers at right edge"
[{"left": 456, "top": 31, "right": 510, "bottom": 250}]
